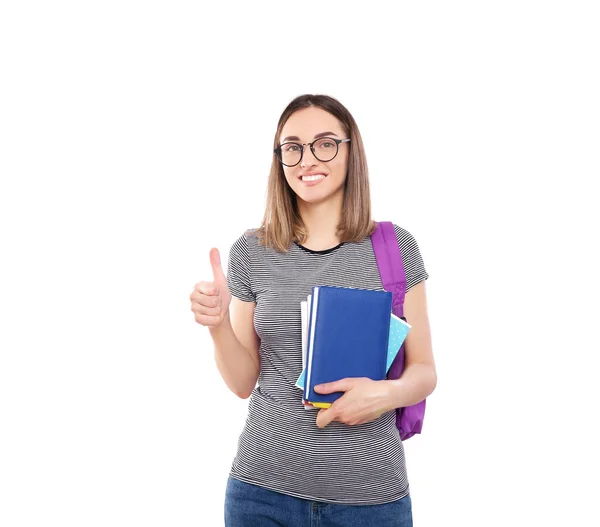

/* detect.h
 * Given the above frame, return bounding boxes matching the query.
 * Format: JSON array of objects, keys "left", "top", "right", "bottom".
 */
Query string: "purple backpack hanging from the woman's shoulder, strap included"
[{"left": 371, "top": 221, "right": 425, "bottom": 441}]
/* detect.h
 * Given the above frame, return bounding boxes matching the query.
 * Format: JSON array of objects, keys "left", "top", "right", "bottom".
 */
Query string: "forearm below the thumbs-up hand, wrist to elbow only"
[{"left": 210, "top": 316, "right": 260, "bottom": 399}]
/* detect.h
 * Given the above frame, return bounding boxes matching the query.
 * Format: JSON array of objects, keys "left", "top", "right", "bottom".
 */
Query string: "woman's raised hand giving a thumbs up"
[{"left": 190, "top": 249, "right": 231, "bottom": 328}]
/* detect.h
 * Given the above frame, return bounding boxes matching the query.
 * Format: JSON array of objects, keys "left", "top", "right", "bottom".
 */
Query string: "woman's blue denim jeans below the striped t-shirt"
[{"left": 225, "top": 477, "right": 412, "bottom": 527}]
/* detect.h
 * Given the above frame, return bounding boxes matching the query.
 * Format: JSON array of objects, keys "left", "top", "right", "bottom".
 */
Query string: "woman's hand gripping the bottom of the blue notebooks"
[{"left": 315, "top": 377, "right": 391, "bottom": 428}]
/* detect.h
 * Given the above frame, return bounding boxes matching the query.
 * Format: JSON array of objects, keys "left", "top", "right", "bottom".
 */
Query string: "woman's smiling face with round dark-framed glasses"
[{"left": 279, "top": 106, "right": 349, "bottom": 204}]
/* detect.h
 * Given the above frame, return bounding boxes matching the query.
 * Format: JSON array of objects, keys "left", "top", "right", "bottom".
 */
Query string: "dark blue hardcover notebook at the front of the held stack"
[{"left": 304, "top": 286, "right": 392, "bottom": 403}]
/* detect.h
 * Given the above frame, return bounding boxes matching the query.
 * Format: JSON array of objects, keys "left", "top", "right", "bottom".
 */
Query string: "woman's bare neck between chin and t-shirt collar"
[{"left": 298, "top": 193, "right": 344, "bottom": 251}]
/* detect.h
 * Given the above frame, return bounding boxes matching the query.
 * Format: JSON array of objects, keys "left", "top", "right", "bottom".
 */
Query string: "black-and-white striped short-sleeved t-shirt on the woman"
[{"left": 227, "top": 225, "right": 428, "bottom": 504}]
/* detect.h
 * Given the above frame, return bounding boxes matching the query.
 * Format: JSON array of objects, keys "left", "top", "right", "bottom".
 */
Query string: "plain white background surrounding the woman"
[{"left": 0, "top": 0, "right": 600, "bottom": 527}]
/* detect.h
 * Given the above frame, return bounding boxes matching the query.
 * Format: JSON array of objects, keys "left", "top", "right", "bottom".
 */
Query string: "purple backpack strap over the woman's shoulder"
[{"left": 371, "top": 221, "right": 406, "bottom": 318}]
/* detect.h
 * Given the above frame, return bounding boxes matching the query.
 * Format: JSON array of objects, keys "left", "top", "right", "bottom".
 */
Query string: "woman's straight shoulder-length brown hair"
[{"left": 256, "top": 94, "right": 375, "bottom": 252}]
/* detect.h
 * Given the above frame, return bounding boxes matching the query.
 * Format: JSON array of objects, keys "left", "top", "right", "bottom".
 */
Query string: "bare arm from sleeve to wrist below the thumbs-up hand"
[{"left": 210, "top": 297, "right": 260, "bottom": 399}]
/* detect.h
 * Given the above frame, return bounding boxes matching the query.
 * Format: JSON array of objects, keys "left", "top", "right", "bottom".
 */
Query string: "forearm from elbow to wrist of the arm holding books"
[{"left": 383, "top": 363, "right": 437, "bottom": 410}]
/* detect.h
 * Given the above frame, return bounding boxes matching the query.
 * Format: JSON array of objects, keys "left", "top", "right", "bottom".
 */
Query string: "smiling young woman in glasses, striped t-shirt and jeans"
[{"left": 190, "top": 95, "right": 436, "bottom": 527}]
